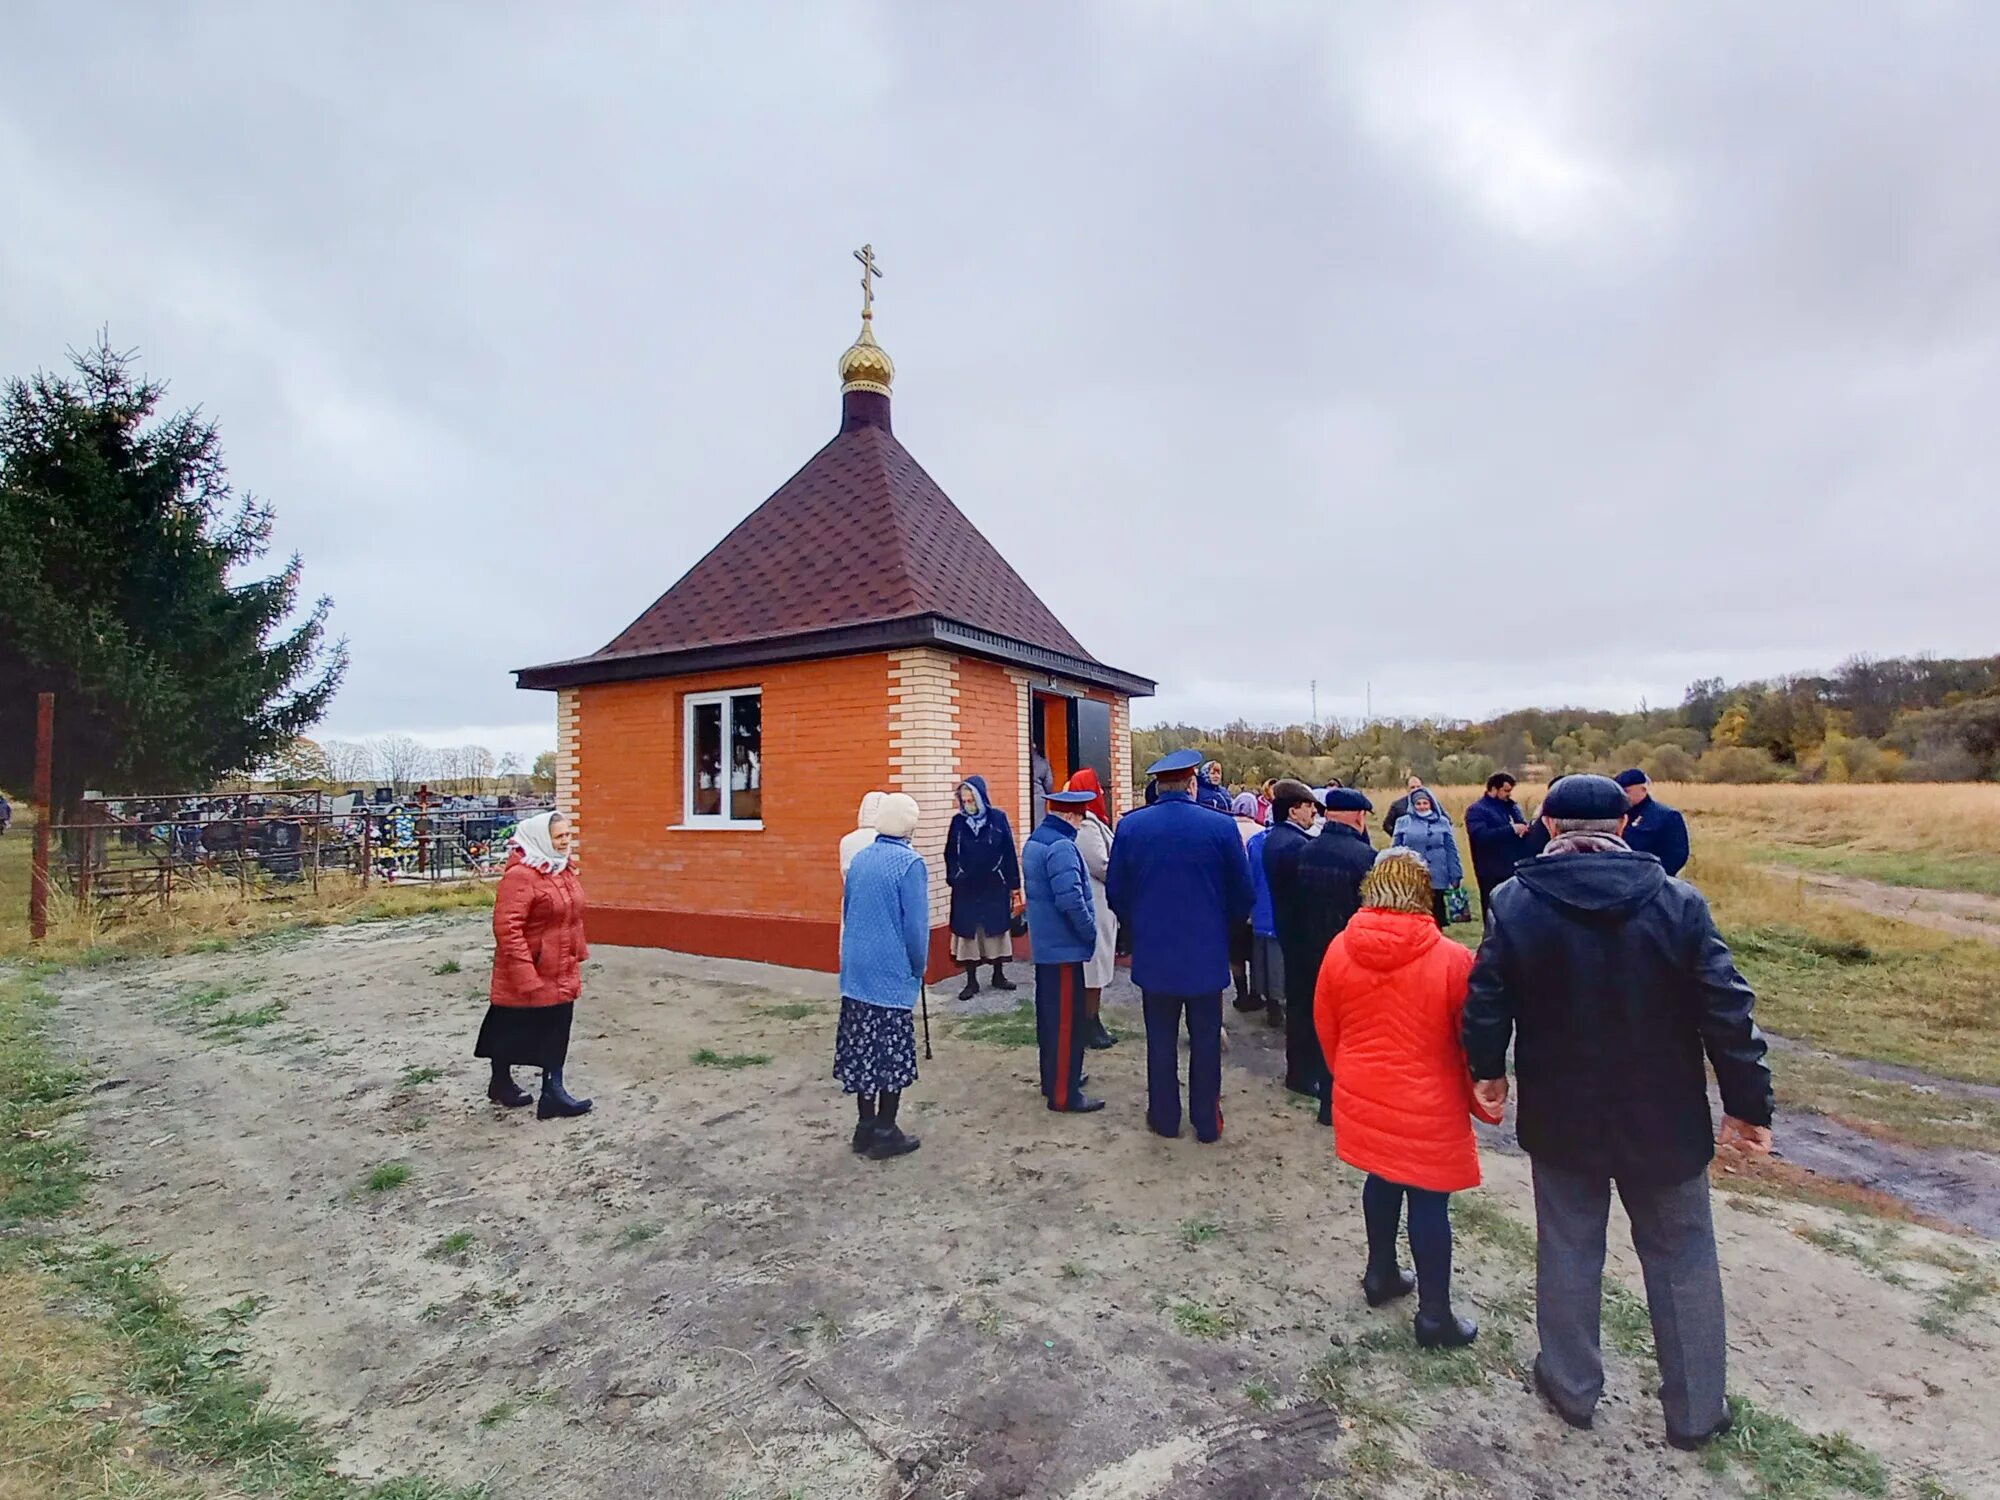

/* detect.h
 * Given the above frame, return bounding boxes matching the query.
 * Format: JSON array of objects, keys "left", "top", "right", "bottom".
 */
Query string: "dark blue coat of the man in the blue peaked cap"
[{"left": 1104, "top": 792, "right": 1252, "bottom": 994}]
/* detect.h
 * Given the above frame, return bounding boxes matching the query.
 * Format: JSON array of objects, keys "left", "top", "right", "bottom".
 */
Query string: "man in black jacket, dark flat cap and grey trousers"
[{"left": 1464, "top": 776, "right": 1772, "bottom": 1448}]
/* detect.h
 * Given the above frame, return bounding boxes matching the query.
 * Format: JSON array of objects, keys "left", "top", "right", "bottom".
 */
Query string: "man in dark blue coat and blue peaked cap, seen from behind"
[{"left": 1104, "top": 750, "right": 1252, "bottom": 1142}]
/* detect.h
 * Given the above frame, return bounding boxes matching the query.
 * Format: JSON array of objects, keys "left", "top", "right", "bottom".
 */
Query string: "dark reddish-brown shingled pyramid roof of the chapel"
[{"left": 516, "top": 392, "right": 1154, "bottom": 694}]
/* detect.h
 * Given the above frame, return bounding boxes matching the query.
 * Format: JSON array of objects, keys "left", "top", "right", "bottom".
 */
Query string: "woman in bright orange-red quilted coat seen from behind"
[{"left": 1312, "top": 848, "right": 1480, "bottom": 1348}]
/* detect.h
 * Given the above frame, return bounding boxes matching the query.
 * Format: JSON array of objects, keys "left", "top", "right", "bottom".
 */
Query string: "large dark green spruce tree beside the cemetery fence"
[{"left": 0, "top": 336, "right": 346, "bottom": 808}]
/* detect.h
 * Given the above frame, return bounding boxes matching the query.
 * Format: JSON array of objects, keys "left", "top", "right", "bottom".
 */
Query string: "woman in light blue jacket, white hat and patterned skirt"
[{"left": 834, "top": 792, "right": 930, "bottom": 1162}]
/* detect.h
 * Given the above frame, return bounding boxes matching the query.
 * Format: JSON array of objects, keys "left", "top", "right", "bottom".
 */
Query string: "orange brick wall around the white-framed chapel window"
[{"left": 578, "top": 656, "right": 890, "bottom": 924}]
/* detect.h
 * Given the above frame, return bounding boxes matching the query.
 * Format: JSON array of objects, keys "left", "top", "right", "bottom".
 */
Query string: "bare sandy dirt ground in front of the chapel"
[{"left": 54, "top": 918, "right": 2000, "bottom": 1500}]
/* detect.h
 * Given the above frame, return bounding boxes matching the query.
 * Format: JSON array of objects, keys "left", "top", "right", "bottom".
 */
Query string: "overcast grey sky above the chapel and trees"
[{"left": 0, "top": 0, "right": 2000, "bottom": 752}]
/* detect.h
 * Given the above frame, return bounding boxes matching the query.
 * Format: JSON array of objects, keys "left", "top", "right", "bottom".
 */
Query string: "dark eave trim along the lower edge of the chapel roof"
[{"left": 514, "top": 614, "right": 1158, "bottom": 698}]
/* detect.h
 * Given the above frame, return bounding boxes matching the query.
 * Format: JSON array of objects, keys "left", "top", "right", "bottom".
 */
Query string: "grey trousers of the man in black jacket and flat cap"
[{"left": 1534, "top": 1160, "right": 1728, "bottom": 1438}]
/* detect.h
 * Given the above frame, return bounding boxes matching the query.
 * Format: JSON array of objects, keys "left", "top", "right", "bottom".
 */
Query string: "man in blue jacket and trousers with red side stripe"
[{"left": 1020, "top": 792, "right": 1104, "bottom": 1114}]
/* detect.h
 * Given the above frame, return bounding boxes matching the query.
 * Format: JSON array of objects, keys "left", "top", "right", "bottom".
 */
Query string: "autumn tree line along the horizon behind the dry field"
[{"left": 1132, "top": 656, "right": 2000, "bottom": 786}]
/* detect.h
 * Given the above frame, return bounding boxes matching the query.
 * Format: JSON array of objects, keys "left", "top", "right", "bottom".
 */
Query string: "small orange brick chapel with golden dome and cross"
[{"left": 516, "top": 248, "right": 1154, "bottom": 978}]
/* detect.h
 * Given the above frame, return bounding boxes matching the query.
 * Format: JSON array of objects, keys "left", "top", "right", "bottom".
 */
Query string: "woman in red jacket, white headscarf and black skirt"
[{"left": 472, "top": 812, "right": 590, "bottom": 1120}]
